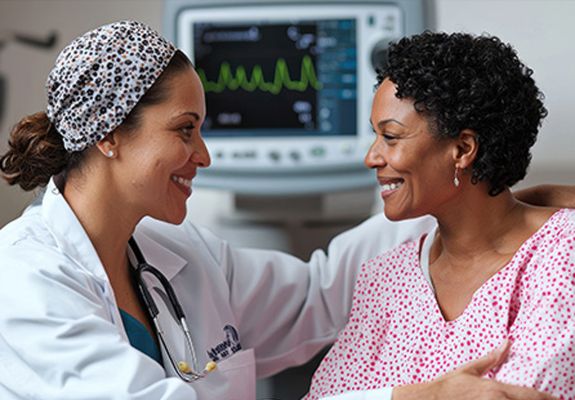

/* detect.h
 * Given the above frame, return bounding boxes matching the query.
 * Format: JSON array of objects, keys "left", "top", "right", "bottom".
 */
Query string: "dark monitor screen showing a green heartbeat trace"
[{"left": 193, "top": 18, "right": 358, "bottom": 138}]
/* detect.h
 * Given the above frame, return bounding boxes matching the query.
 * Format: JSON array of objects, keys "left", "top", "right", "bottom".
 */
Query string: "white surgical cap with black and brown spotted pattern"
[{"left": 46, "top": 21, "right": 176, "bottom": 152}]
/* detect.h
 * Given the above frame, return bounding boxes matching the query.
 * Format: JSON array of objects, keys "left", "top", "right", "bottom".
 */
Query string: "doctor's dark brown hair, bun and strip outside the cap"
[{"left": 0, "top": 50, "right": 193, "bottom": 191}]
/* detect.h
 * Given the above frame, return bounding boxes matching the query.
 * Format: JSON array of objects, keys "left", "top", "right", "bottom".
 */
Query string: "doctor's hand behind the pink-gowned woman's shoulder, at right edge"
[{"left": 513, "top": 185, "right": 575, "bottom": 208}]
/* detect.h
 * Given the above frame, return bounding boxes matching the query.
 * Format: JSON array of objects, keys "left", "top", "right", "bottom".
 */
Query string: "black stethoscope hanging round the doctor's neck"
[{"left": 129, "top": 237, "right": 216, "bottom": 382}]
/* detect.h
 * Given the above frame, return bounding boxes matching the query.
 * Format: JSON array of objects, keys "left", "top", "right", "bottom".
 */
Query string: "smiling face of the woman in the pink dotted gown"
[{"left": 365, "top": 79, "right": 456, "bottom": 220}]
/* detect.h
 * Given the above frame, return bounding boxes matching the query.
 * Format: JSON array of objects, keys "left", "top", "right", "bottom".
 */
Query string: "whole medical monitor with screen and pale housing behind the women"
[{"left": 164, "top": 0, "right": 423, "bottom": 195}]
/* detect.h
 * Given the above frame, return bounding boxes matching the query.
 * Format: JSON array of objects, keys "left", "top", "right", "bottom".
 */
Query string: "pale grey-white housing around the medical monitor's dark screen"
[{"left": 166, "top": 0, "right": 423, "bottom": 196}]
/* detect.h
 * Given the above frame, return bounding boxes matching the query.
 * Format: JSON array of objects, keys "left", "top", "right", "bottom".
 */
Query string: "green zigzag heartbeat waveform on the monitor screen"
[{"left": 198, "top": 56, "right": 322, "bottom": 94}]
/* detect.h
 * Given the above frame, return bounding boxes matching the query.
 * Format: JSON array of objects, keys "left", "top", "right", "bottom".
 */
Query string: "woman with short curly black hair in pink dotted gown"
[{"left": 307, "top": 32, "right": 575, "bottom": 400}]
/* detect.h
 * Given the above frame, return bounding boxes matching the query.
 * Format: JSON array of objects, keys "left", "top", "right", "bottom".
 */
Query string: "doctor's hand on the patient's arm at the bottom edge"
[{"left": 392, "top": 342, "right": 557, "bottom": 400}]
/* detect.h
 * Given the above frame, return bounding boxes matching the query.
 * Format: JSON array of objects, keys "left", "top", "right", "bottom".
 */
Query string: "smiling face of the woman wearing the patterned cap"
[{"left": 112, "top": 67, "right": 210, "bottom": 223}]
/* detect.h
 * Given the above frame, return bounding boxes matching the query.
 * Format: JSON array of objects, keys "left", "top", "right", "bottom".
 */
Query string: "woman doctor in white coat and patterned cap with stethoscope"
[{"left": 0, "top": 21, "right": 568, "bottom": 400}]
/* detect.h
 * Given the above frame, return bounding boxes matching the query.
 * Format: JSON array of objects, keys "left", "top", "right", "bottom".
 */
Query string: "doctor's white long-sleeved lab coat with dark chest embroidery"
[{"left": 0, "top": 181, "right": 434, "bottom": 400}]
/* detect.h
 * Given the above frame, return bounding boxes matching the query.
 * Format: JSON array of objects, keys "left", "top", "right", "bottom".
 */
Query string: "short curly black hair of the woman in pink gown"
[{"left": 377, "top": 32, "right": 547, "bottom": 196}]
